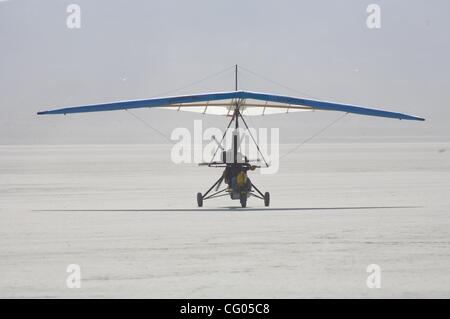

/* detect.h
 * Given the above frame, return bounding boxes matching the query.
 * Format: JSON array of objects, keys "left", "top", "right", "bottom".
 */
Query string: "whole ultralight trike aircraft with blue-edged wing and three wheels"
[{"left": 37, "top": 65, "right": 424, "bottom": 207}]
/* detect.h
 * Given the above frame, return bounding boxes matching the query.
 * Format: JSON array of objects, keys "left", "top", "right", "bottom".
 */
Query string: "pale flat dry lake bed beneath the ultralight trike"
[{"left": 0, "top": 143, "right": 450, "bottom": 298}]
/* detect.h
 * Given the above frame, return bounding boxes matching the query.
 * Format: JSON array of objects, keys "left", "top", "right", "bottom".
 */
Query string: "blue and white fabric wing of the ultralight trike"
[{"left": 38, "top": 91, "right": 424, "bottom": 121}]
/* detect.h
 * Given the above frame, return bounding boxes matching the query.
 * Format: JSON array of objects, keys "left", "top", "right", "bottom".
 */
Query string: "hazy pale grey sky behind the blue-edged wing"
[{"left": 0, "top": 0, "right": 450, "bottom": 144}]
